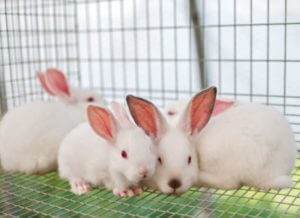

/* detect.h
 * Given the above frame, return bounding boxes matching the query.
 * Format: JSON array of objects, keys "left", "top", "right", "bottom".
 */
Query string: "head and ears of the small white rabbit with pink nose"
[{"left": 88, "top": 102, "right": 156, "bottom": 183}]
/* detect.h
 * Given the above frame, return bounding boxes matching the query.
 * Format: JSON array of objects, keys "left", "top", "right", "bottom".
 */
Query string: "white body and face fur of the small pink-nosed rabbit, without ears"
[{"left": 58, "top": 116, "right": 156, "bottom": 195}]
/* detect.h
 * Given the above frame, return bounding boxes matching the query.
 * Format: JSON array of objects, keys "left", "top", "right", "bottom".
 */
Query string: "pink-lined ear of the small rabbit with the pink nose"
[{"left": 87, "top": 105, "right": 117, "bottom": 143}]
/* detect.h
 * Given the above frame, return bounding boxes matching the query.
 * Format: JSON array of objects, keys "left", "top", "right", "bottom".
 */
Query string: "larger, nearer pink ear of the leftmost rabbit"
[{"left": 45, "top": 68, "right": 71, "bottom": 100}]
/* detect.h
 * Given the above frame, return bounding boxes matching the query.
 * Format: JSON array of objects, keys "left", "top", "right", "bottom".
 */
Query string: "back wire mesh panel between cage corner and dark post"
[{"left": 77, "top": 0, "right": 200, "bottom": 105}]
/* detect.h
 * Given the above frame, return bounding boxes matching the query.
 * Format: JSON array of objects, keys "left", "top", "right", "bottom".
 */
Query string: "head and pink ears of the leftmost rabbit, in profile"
[{"left": 37, "top": 68, "right": 105, "bottom": 105}]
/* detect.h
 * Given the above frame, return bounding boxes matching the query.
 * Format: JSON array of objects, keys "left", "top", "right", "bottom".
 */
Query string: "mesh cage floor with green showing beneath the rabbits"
[{"left": 0, "top": 155, "right": 300, "bottom": 218}]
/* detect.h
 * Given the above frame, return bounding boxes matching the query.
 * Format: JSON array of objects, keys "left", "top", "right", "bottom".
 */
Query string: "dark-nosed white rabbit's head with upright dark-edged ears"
[{"left": 127, "top": 87, "right": 216, "bottom": 194}]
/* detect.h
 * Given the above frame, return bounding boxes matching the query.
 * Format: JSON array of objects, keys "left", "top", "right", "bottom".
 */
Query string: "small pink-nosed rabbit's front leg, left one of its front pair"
[{"left": 111, "top": 172, "right": 135, "bottom": 198}]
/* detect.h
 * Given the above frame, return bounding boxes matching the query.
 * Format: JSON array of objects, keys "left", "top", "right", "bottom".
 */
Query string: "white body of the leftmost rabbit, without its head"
[{"left": 0, "top": 102, "right": 86, "bottom": 173}]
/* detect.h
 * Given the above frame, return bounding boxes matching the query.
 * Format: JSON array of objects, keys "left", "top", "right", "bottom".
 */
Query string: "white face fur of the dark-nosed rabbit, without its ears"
[{"left": 146, "top": 125, "right": 198, "bottom": 194}]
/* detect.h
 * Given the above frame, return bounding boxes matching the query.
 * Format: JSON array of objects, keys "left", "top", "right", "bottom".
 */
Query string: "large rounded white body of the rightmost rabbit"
[{"left": 197, "top": 103, "right": 296, "bottom": 189}]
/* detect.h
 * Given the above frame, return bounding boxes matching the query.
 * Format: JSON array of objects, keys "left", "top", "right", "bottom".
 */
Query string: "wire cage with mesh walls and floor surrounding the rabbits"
[{"left": 0, "top": 0, "right": 300, "bottom": 217}]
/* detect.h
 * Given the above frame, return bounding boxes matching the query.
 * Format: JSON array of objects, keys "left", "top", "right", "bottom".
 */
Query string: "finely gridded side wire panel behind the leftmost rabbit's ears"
[{"left": 0, "top": 0, "right": 78, "bottom": 112}]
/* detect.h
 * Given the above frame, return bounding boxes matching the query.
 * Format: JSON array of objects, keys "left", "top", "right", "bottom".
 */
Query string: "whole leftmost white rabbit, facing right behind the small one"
[{"left": 0, "top": 68, "right": 103, "bottom": 173}]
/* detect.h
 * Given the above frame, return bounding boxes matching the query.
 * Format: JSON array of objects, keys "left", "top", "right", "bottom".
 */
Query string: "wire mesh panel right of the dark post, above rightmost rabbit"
[{"left": 197, "top": 0, "right": 300, "bottom": 146}]
